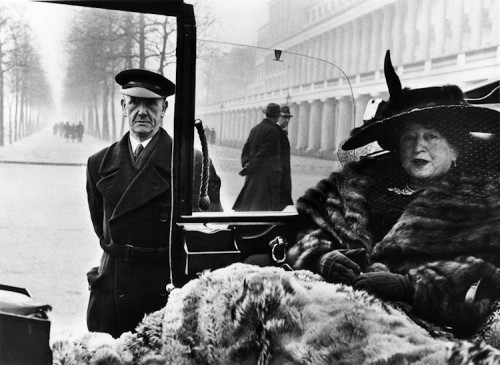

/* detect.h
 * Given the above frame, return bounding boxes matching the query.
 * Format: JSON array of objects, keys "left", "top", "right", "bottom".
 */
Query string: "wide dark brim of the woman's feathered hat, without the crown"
[{"left": 342, "top": 105, "right": 500, "bottom": 150}]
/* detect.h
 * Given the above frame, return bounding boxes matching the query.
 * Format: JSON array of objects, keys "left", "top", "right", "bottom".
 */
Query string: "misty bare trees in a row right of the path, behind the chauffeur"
[{"left": 64, "top": 3, "right": 213, "bottom": 141}]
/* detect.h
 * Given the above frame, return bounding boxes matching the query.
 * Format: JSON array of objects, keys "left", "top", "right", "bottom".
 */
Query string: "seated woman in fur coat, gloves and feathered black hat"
[{"left": 287, "top": 55, "right": 500, "bottom": 337}]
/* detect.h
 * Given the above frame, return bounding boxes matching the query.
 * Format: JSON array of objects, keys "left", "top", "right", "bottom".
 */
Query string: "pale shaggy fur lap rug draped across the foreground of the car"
[{"left": 52, "top": 264, "right": 500, "bottom": 365}]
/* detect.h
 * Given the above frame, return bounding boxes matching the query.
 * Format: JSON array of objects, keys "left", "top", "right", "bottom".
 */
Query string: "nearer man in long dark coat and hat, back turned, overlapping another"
[{"left": 233, "top": 103, "right": 286, "bottom": 211}]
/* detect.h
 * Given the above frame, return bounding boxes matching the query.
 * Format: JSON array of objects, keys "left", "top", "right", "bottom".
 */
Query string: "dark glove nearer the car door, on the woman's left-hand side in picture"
[{"left": 318, "top": 251, "right": 361, "bottom": 284}]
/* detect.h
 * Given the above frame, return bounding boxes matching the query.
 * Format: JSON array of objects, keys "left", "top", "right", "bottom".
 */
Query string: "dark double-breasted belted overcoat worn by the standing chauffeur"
[{"left": 87, "top": 129, "right": 172, "bottom": 336}]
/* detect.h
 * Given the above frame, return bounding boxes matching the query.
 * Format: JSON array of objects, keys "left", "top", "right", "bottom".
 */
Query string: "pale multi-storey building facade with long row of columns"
[{"left": 198, "top": 0, "right": 500, "bottom": 158}]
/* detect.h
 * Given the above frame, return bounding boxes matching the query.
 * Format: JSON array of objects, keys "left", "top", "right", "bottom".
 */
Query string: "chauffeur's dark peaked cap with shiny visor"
[{"left": 115, "top": 69, "right": 175, "bottom": 98}]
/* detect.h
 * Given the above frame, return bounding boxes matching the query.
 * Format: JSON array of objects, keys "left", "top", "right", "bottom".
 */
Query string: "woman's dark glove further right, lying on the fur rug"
[{"left": 353, "top": 272, "right": 413, "bottom": 302}]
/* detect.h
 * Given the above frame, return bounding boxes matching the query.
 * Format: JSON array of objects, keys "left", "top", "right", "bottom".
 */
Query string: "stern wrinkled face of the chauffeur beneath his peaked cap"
[{"left": 121, "top": 95, "right": 168, "bottom": 141}]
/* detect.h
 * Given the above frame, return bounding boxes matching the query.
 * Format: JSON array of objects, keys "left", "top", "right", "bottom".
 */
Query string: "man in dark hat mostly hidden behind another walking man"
[{"left": 278, "top": 105, "right": 293, "bottom": 206}]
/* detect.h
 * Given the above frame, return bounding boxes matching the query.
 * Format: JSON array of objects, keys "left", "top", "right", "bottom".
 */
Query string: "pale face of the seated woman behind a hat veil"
[{"left": 399, "top": 123, "right": 458, "bottom": 182}]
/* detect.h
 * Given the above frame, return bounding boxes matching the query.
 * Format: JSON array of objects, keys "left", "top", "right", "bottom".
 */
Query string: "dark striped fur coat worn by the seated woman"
[{"left": 288, "top": 156, "right": 500, "bottom": 337}]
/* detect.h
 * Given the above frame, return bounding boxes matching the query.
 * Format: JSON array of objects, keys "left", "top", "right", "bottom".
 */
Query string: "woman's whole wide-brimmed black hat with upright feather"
[{"left": 342, "top": 51, "right": 500, "bottom": 151}]
